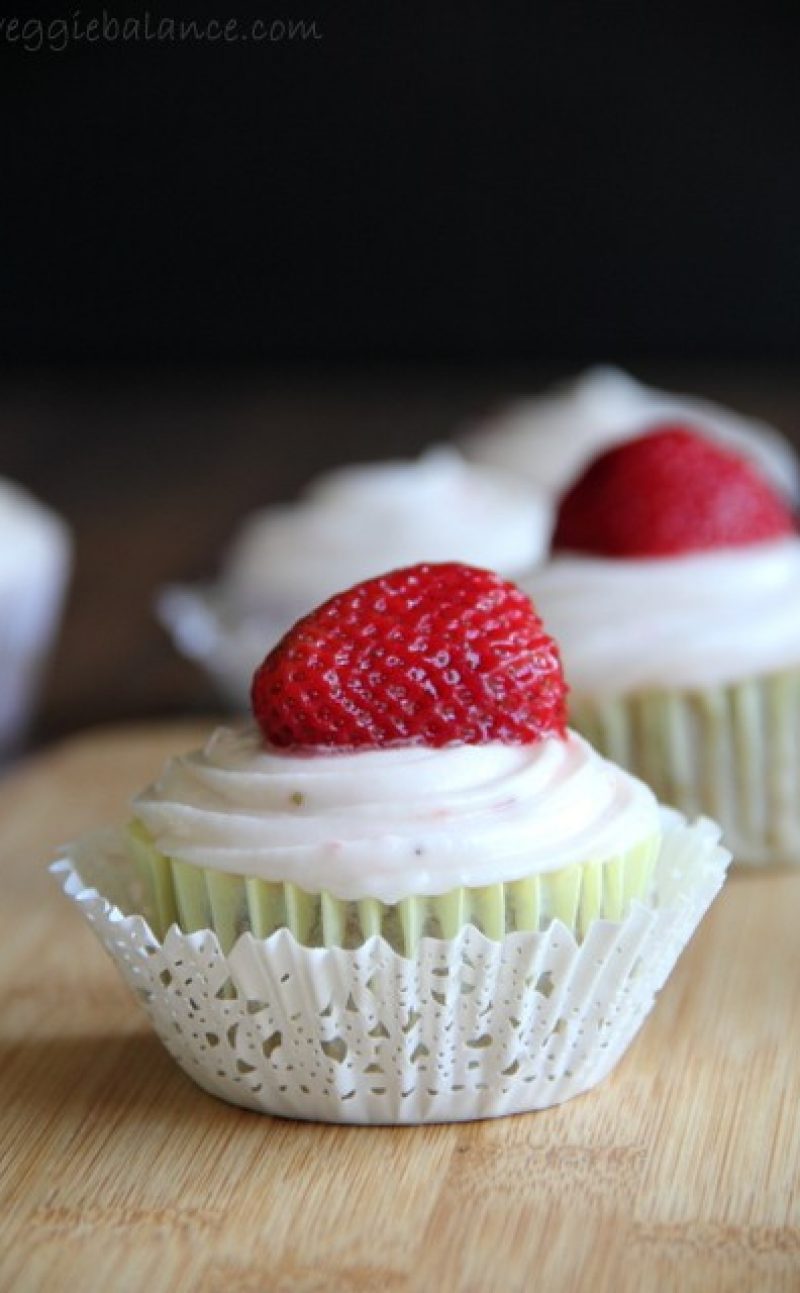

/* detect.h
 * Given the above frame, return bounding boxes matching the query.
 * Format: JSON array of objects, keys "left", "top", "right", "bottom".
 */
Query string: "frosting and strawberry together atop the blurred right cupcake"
[{"left": 527, "top": 427, "right": 800, "bottom": 696}]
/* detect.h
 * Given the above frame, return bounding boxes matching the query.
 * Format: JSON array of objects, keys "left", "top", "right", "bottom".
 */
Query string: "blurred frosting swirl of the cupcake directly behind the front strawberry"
[{"left": 224, "top": 449, "right": 552, "bottom": 612}]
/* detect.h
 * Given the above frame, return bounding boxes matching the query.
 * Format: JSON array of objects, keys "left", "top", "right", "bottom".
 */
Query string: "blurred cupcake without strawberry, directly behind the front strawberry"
[{"left": 158, "top": 447, "right": 552, "bottom": 709}]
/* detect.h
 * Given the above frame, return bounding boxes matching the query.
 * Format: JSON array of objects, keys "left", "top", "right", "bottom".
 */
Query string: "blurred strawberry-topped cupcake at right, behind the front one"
[{"left": 527, "top": 427, "right": 800, "bottom": 865}]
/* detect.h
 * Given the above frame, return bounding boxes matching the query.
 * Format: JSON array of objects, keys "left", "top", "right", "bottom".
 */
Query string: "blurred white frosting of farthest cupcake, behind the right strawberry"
[{"left": 464, "top": 367, "right": 800, "bottom": 499}]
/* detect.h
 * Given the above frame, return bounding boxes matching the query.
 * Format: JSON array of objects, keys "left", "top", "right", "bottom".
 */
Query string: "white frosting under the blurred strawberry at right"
[{"left": 525, "top": 538, "right": 800, "bottom": 694}]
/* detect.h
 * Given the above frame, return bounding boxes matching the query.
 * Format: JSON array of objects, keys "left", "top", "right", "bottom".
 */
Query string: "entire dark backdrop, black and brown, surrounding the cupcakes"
[{"left": 0, "top": 0, "right": 800, "bottom": 741}]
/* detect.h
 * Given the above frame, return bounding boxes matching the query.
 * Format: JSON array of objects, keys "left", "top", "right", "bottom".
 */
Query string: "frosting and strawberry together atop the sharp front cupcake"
[{"left": 134, "top": 564, "right": 658, "bottom": 903}]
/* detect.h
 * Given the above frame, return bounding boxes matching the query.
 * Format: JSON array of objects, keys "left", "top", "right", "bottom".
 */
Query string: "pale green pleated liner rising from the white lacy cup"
[{"left": 128, "top": 821, "right": 660, "bottom": 956}]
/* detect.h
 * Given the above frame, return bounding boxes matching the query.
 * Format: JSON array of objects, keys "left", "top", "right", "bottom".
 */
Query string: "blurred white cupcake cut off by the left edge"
[{"left": 0, "top": 480, "right": 72, "bottom": 758}]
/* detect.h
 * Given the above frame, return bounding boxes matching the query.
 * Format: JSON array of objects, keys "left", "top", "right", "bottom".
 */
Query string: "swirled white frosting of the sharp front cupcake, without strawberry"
[{"left": 134, "top": 727, "right": 658, "bottom": 903}]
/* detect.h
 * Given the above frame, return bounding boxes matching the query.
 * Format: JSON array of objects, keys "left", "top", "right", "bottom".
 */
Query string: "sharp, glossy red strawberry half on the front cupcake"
[{"left": 252, "top": 562, "right": 566, "bottom": 749}]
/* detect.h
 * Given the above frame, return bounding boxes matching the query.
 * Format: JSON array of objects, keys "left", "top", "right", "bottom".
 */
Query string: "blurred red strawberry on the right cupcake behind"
[{"left": 553, "top": 425, "right": 795, "bottom": 557}]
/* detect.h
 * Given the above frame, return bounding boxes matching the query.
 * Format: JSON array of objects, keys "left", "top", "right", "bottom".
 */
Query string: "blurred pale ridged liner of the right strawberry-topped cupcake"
[{"left": 570, "top": 670, "right": 800, "bottom": 866}]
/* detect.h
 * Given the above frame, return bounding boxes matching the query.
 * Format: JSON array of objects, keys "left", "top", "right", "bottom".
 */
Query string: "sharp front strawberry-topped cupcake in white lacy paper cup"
[{"left": 56, "top": 564, "right": 728, "bottom": 1122}]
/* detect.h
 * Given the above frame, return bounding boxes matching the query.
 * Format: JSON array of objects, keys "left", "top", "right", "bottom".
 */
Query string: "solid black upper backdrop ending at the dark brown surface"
[{"left": 0, "top": 0, "right": 800, "bottom": 365}]
